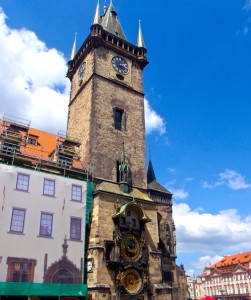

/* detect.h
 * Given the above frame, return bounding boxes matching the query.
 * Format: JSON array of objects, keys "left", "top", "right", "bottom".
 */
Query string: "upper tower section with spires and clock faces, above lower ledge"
[{"left": 67, "top": 3, "right": 147, "bottom": 188}]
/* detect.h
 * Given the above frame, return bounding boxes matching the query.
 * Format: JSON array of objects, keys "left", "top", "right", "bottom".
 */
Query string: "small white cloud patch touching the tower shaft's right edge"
[{"left": 145, "top": 99, "right": 166, "bottom": 135}]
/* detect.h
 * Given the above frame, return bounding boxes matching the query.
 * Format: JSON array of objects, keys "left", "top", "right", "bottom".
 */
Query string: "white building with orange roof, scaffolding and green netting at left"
[{"left": 0, "top": 115, "right": 92, "bottom": 299}]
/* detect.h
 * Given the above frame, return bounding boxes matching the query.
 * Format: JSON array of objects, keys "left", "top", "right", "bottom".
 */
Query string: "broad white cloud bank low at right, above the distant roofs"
[{"left": 173, "top": 203, "right": 251, "bottom": 255}]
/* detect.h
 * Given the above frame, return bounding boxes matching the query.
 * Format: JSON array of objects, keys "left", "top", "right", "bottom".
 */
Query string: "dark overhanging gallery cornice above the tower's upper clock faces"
[{"left": 67, "top": 24, "right": 148, "bottom": 80}]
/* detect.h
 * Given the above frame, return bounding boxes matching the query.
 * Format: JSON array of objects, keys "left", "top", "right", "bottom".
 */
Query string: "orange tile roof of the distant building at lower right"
[{"left": 210, "top": 251, "right": 251, "bottom": 268}]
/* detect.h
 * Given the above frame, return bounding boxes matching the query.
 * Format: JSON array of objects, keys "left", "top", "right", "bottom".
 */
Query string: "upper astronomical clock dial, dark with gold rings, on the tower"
[{"left": 121, "top": 234, "right": 142, "bottom": 261}]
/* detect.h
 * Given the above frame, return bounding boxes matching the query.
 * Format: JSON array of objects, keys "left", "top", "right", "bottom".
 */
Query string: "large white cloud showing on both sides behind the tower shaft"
[{"left": 0, "top": 8, "right": 165, "bottom": 134}]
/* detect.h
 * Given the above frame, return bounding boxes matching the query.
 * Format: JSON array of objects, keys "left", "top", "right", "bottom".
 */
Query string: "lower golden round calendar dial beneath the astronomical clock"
[{"left": 121, "top": 269, "right": 143, "bottom": 295}]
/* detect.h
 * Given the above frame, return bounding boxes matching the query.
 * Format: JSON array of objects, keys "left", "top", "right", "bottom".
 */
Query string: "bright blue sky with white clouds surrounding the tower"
[{"left": 0, "top": 0, "right": 251, "bottom": 275}]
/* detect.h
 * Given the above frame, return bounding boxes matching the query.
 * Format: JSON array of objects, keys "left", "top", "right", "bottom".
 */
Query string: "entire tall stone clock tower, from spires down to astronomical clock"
[{"left": 67, "top": 2, "right": 185, "bottom": 300}]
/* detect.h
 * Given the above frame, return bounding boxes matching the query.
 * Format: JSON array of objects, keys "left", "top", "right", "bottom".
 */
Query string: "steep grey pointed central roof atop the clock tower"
[{"left": 100, "top": 1, "right": 126, "bottom": 40}]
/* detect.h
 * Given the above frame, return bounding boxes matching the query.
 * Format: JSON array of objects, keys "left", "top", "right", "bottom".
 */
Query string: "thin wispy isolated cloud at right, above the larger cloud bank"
[{"left": 202, "top": 169, "right": 251, "bottom": 190}]
